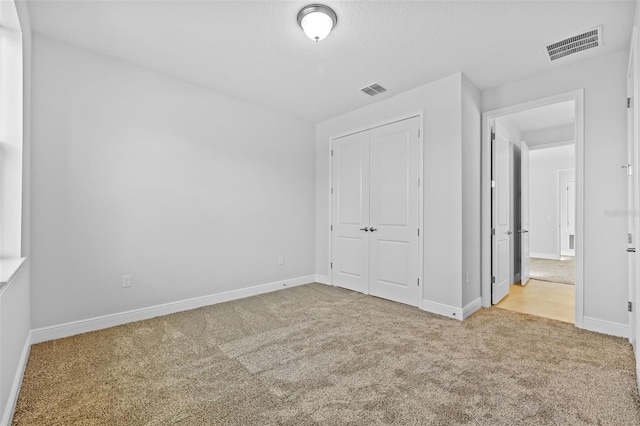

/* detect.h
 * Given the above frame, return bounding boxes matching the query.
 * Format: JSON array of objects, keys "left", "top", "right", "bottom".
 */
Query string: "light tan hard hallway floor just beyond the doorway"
[{"left": 496, "top": 279, "right": 575, "bottom": 324}]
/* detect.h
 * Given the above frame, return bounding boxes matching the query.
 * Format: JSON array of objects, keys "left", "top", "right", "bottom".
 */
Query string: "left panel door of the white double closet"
[{"left": 331, "top": 131, "right": 369, "bottom": 294}]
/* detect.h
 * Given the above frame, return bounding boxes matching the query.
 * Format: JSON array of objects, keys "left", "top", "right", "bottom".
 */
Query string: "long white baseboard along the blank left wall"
[{"left": 31, "top": 275, "right": 316, "bottom": 344}]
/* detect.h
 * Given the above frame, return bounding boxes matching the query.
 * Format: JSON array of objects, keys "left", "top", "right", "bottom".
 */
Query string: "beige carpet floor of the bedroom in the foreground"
[{"left": 13, "top": 284, "right": 640, "bottom": 425}]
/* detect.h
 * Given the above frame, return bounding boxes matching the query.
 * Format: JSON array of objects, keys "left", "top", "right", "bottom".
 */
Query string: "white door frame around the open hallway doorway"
[{"left": 480, "top": 89, "right": 584, "bottom": 328}]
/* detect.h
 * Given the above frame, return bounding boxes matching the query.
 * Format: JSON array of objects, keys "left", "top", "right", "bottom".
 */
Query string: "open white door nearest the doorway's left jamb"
[{"left": 491, "top": 124, "right": 512, "bottom": 304}]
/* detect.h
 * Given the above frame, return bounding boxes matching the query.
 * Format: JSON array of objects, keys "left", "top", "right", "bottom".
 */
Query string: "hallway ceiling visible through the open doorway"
[{"left": 505, "top": 101, "right": 576, "bottom": 133}]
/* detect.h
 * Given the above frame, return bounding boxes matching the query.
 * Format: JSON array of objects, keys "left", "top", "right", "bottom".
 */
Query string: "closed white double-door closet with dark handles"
[{"left": 330, "top": 117, "right": 422, "bottom": 306}]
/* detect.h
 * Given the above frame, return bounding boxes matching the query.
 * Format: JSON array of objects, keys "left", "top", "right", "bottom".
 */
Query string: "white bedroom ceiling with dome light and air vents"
[{"left": 28, "top": 0, "right": 635, "bottom": 122}]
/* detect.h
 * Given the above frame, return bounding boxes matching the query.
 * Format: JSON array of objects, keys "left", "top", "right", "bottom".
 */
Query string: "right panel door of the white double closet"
[{"left": 369, "top": 117, "right": 420, "bottom": 306}]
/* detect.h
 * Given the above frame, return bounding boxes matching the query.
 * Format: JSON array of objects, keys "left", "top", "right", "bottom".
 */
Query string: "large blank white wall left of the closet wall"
[{"left": 32, "top": 35, "right": 315, "bottom": 328}]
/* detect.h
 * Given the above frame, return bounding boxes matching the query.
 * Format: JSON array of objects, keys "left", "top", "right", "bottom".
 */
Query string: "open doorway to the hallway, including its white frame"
[{"left": 482, "top": 91, "right": 583, "bottom": 327}]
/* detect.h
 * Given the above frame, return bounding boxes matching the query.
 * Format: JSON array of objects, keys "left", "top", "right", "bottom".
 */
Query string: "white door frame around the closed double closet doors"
[{"left": 327, "top": 110, "right": 425, "bottom": 309}]
